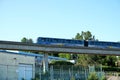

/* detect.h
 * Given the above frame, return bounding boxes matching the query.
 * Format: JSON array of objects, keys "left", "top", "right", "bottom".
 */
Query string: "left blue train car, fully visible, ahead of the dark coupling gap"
[{"left": 37, "top": 37, "right": 84, "bottom": 46}]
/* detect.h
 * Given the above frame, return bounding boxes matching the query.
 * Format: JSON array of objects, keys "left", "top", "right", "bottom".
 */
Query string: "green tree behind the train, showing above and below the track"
[{"left": 73, "top": 31, "right": 95, "bottom": 66}]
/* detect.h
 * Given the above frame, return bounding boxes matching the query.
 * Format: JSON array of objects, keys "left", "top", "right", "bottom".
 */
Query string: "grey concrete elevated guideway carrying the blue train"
[{"left": 0, "top": 41, "right": 120, "bottom": 55}]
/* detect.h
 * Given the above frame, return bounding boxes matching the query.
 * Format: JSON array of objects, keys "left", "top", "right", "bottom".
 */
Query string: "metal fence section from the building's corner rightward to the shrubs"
[{"left": 36, "top": 65, "right": 104, "bottom": 80}]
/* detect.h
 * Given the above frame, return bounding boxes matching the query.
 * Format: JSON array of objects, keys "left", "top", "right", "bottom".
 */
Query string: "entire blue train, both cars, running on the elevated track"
[{"left": 37, "top": 37, "right": 120, "bottom": 49}]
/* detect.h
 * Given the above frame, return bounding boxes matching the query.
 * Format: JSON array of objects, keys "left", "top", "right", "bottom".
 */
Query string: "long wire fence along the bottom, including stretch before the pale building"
[{"left": 0, "top": 65, "right": 103, "bottom": 80}]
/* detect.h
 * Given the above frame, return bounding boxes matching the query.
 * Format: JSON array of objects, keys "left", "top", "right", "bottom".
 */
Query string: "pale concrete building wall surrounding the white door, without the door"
[{"left": 0, "top": 52, "right": 35, "bottom": 80}]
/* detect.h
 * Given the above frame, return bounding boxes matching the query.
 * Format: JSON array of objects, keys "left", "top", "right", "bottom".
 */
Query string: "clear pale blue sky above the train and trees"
[{"left": 0, "top": 0, "right": 120, "bottom": 41}]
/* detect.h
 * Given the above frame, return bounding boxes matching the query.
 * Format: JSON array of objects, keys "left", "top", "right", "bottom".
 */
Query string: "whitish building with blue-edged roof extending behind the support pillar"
[{"left": 0, "top": 50, "right": 67, "bottom": 80}]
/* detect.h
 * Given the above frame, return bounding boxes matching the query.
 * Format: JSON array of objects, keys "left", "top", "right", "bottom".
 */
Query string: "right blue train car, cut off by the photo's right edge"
[{"left": 88, "top": 41, "right": 120, "bottom": 48}]
